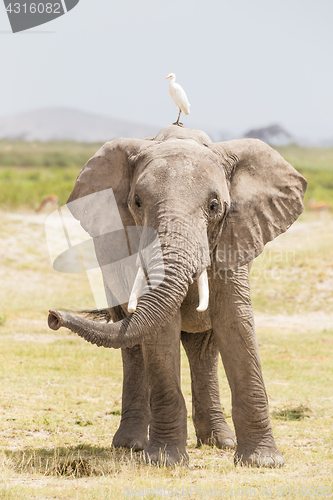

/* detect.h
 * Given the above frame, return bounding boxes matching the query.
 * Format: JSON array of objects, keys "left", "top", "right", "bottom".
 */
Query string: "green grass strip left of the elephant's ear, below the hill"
[{"left": 0, "top": 140, "right": 101, "bottom": 209}]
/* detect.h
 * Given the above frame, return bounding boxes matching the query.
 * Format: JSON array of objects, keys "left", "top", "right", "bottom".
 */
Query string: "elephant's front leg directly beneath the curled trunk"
[{"left": 143, "top": 310, "right": 188, "bottom": 465}]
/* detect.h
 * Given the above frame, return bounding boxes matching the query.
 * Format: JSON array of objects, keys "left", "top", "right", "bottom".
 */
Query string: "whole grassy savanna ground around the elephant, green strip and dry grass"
[{"left": 0, "top": 141, "right": 333, "bottom": 500}]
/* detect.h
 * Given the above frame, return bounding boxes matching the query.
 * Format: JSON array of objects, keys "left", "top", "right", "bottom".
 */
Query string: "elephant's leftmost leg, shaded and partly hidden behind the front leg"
[{"left": 112, "top": 345, "right": 150, "bottom": 451}]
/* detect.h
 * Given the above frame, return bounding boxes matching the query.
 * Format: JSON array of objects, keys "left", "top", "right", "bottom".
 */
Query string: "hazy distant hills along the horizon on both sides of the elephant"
[{"left": 0, "top": 108, "right": 326, "bottom": 147}]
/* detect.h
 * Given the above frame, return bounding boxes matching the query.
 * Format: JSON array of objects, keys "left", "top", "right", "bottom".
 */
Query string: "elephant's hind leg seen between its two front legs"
[{"left": 181, "top": 330, "right": 236, "bottom": 448}]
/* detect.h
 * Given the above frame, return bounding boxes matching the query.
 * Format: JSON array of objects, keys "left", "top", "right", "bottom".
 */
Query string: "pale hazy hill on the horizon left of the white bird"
[{"left": 0, "top": 108, "right": 161, "bottom": 142}]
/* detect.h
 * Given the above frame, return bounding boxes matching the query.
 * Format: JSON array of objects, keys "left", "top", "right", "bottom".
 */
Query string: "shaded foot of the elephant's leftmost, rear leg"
[{"left": 112, "top": 420, "right": 148, "bottom": 451}]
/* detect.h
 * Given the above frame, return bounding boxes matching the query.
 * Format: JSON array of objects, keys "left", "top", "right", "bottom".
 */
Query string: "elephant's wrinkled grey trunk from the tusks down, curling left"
[{"left": 48, "top": 263, "right": 191, "bottom": 348}]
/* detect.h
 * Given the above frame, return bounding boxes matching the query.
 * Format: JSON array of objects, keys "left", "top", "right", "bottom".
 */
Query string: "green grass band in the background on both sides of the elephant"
[{"left": 0, "top": 140, "right": 333, "bottom": 209}]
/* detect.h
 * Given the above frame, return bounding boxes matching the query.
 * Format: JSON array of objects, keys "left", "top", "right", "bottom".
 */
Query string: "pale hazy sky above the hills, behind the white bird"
[{"left": 0, "top": 0, "right": 333, "bottom": 139}]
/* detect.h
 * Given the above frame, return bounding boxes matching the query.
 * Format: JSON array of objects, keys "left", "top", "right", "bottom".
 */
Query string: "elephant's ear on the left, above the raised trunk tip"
[{"left": 67, "top": 139, "right": 147, "bottom": 236}]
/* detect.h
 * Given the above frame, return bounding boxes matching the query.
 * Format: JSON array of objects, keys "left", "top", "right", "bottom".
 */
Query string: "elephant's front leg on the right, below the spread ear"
[{"left": 210, "top": 266, "right": 284, "bottom": 467}]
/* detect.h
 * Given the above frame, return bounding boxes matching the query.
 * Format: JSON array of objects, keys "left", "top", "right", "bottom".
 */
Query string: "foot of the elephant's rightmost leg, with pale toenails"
[{"left": 234, "top": 446, "right": 284, "bottom": 468}]
